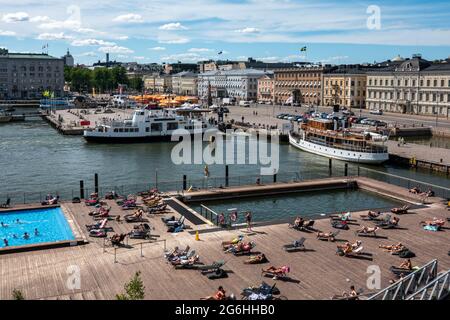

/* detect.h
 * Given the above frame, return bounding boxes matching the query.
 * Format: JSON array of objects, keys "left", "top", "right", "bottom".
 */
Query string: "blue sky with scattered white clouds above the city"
[{"left": 0, "top": 0, "right": 450, "bottom": 64}]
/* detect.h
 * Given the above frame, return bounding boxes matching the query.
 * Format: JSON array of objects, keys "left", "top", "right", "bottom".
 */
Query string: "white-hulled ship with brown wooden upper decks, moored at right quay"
[{"left": 289, "top": 119, "right": 389, "bottom": 164}]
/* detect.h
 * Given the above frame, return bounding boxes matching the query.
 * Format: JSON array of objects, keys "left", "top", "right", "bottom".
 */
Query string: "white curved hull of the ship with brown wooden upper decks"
[{"left": 289, "top": 135, "right": 389, "bottom": 164}]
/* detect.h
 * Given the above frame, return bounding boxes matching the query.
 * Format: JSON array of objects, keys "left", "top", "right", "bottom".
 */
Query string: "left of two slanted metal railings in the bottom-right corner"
[{"left": 368, "top": 259, "right": 438, "bottom": 300}]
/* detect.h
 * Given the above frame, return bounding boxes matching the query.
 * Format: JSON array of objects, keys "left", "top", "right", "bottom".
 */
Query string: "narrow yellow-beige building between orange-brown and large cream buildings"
[{"left": 322, "top": 68, "right": 367, "bottom": 109}]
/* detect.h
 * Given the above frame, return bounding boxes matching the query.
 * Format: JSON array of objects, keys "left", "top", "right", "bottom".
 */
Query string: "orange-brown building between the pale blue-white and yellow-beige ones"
[{"left": 274, "top": 65, "right": 330, "bottom": 106}]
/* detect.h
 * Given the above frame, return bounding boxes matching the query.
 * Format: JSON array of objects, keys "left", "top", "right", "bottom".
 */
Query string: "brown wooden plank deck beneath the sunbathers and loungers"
[{"left": 0, "top": 182, "right": 450, "bottom": 299}]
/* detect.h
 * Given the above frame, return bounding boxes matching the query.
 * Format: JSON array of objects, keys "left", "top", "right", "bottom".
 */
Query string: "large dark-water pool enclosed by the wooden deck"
[{"left": 195, "top": 189, "right": 401, "bottom": 223}]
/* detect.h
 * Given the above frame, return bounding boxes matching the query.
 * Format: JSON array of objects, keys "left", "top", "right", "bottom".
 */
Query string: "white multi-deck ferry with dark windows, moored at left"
[{"left": 84, "top": 108, "right": 215, "bottom": 143}]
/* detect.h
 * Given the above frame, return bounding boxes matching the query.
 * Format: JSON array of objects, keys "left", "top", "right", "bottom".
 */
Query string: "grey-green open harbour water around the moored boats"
[{"left": 0, "top": 110, "right": 450, "bottom": 202}]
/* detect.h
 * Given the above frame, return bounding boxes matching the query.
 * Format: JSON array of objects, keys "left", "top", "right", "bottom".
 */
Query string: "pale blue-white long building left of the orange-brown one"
[{"left": 198, "top": 69, "right": 266, "bottom": 101}]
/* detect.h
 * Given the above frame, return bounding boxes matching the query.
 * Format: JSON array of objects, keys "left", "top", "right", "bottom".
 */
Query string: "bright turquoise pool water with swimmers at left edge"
[{"left": 0, "top": 208, "right": 75, "bottom": 248}]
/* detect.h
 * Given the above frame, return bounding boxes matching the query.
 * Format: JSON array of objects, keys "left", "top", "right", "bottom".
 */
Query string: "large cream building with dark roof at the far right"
[{"left": 367, "top": 55, "right": 450, "bottom": 117}]
